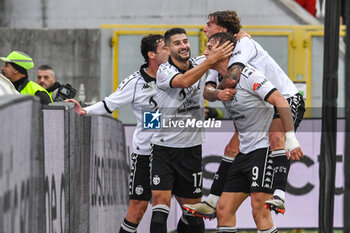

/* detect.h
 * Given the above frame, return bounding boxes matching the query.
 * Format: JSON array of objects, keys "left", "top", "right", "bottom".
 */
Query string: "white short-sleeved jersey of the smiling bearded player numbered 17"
[{"left": 152, "top": 56, "right": 205, "bottom": 148}]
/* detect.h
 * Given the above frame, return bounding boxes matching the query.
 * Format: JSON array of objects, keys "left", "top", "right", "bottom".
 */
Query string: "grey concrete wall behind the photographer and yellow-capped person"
[{"left": 0, "top": 28, "right": 101, "bottom": 101}]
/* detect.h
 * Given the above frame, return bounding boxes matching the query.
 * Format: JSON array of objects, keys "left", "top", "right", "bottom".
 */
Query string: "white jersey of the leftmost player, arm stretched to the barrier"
[{"left": 85, "top": 65, "right": 157, "bottom": 155}]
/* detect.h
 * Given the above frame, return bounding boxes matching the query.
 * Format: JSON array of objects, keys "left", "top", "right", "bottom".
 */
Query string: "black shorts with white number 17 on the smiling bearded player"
[{"left": 151, "top": 145, "right": 203, "bottom": 198}]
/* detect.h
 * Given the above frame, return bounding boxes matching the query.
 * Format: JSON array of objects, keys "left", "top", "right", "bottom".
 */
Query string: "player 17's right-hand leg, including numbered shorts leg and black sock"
[{"left": 173, "top": 146, "right": 205, "bottom": 233}]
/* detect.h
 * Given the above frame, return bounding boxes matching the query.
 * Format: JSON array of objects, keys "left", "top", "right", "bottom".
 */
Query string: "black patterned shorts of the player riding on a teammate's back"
[{"left": 273, "top": 93, "right": 305, "bottom": 131}]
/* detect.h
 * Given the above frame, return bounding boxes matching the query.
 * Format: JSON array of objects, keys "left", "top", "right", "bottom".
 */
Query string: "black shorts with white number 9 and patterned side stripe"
[{"left": 224, "top": 148, "right": 274, "bottom": 193}]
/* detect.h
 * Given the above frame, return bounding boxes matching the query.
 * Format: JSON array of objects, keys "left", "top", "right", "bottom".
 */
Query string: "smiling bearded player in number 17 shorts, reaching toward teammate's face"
[{"left": 150, "top": 28, "right": 233, "bottom": 233}]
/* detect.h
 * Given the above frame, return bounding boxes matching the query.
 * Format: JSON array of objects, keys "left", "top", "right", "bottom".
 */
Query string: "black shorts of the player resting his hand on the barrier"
[{"left": 129, "top": 153, "right": 152, "bottom": 201}]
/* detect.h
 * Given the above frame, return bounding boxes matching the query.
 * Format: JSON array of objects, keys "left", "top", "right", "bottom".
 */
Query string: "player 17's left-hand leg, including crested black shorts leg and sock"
[{"left": 150, "top": 145, "right": 176, "bottom": 233}]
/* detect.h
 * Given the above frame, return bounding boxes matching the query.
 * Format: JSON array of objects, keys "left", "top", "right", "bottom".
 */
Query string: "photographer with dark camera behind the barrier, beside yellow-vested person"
[{"left": 37, "top": 65, "right": 77, "bottom": 102}]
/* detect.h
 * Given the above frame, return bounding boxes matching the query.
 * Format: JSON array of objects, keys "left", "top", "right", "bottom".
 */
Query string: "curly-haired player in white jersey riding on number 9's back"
[{"left": 184, "top": 10, "right": 305, "bottom": 218}]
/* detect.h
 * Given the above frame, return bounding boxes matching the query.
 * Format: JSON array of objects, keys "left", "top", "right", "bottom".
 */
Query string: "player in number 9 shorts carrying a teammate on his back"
[{"left": 205, "top": 33, "right": 302, "bottom": 233}]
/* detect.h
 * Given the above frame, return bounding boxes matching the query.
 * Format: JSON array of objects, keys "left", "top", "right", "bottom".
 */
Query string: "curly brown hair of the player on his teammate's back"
[{"left": 208, "top": 10, "right": 242, "bottom": 34}]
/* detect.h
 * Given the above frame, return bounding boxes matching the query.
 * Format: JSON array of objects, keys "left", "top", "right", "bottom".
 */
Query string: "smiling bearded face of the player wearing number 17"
[{"left": 169, "top": 34, "right": 191, "bottom": 61}]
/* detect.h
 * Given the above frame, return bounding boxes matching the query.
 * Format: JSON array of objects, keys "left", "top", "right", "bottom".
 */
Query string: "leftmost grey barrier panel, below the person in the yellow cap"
[{"left": 0, "top": 95, "right": 45, "bottom": 233}]
